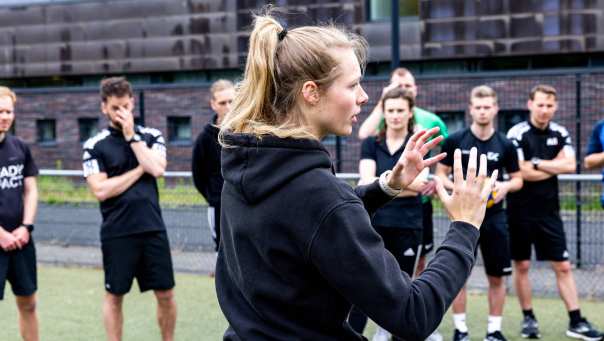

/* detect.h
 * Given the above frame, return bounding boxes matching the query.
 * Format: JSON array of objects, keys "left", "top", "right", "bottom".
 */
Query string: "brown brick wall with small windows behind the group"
[{"left": 10, "top": 74, "right": 604, "bottom": 172}]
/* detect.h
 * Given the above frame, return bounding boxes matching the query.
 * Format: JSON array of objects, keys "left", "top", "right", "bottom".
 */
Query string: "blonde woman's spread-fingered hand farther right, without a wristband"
[{"left": 434, "top": 148, "right": 497, "bottom": 228}]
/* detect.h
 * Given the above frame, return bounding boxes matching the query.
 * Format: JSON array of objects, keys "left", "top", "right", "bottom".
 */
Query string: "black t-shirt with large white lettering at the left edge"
[{"left": 0, "top": 134, "right": 38, "bottom": 232}]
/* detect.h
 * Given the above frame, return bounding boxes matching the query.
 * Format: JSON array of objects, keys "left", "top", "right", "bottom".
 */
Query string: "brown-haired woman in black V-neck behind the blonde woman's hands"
[{"left": 349, "top": 88, "right": 428, "bottom": 339}]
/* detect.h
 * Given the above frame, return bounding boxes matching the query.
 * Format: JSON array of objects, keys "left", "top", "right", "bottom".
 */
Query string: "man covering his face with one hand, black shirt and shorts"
[{"left": 83, "top": 77, "right": 176, "bottom": 340}]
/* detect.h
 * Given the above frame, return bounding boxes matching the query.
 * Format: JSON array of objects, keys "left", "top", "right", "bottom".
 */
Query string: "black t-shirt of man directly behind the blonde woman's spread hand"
[{"left": 440, "top": 128, "right": 520, "bottom": 215}]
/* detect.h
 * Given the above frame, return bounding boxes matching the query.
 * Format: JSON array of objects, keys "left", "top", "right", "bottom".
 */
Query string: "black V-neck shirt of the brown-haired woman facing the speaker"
[{"left": 361, "top": 136, "right": 423, "bottom": 230}]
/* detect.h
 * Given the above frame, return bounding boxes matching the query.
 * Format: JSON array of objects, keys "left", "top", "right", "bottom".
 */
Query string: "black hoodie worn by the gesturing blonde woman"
[{"left": 216, "top": 134, "right": 479, "bottom": 340}]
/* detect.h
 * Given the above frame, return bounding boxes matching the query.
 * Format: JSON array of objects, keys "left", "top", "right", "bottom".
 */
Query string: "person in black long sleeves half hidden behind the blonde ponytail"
[{"left": 191, "top": 79, "right": 235, "bottom": 258}]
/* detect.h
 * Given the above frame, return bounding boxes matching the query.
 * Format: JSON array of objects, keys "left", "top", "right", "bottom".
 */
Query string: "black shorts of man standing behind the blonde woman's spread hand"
[{"left": 479, "top": 210, "right": 512, "bottom": 277}]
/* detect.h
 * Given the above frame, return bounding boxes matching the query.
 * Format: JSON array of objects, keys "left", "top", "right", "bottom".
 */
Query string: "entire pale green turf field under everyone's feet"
[{"left": 0, "top": 266, "right": 604, "bottom": 341}]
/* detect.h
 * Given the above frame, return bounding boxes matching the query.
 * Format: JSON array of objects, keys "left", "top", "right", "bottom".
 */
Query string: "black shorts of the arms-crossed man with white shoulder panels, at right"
[{"left": 508, "top": 212, "right": 568, "bottom": 262}]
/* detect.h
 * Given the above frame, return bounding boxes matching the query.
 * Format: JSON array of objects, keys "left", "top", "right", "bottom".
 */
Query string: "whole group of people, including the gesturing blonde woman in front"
[{"left": 0, "top": 9, "right": 604, "bottom": 341}]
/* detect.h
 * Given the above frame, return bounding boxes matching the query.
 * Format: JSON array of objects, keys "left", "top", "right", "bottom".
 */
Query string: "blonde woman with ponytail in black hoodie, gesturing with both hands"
[{"left": 216, "top": 9, "right": 493, "bottom": 340}]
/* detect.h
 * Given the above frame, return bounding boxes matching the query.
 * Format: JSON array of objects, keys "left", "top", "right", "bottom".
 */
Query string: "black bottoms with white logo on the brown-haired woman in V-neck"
[{"left": 375, "top": 226, "right": 422, "bottom": 276}]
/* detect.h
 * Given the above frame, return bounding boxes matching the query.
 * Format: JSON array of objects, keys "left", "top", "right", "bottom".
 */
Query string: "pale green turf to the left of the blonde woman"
[{"left": 0, "top": 266, "right": 226, "bottom": 341}]
